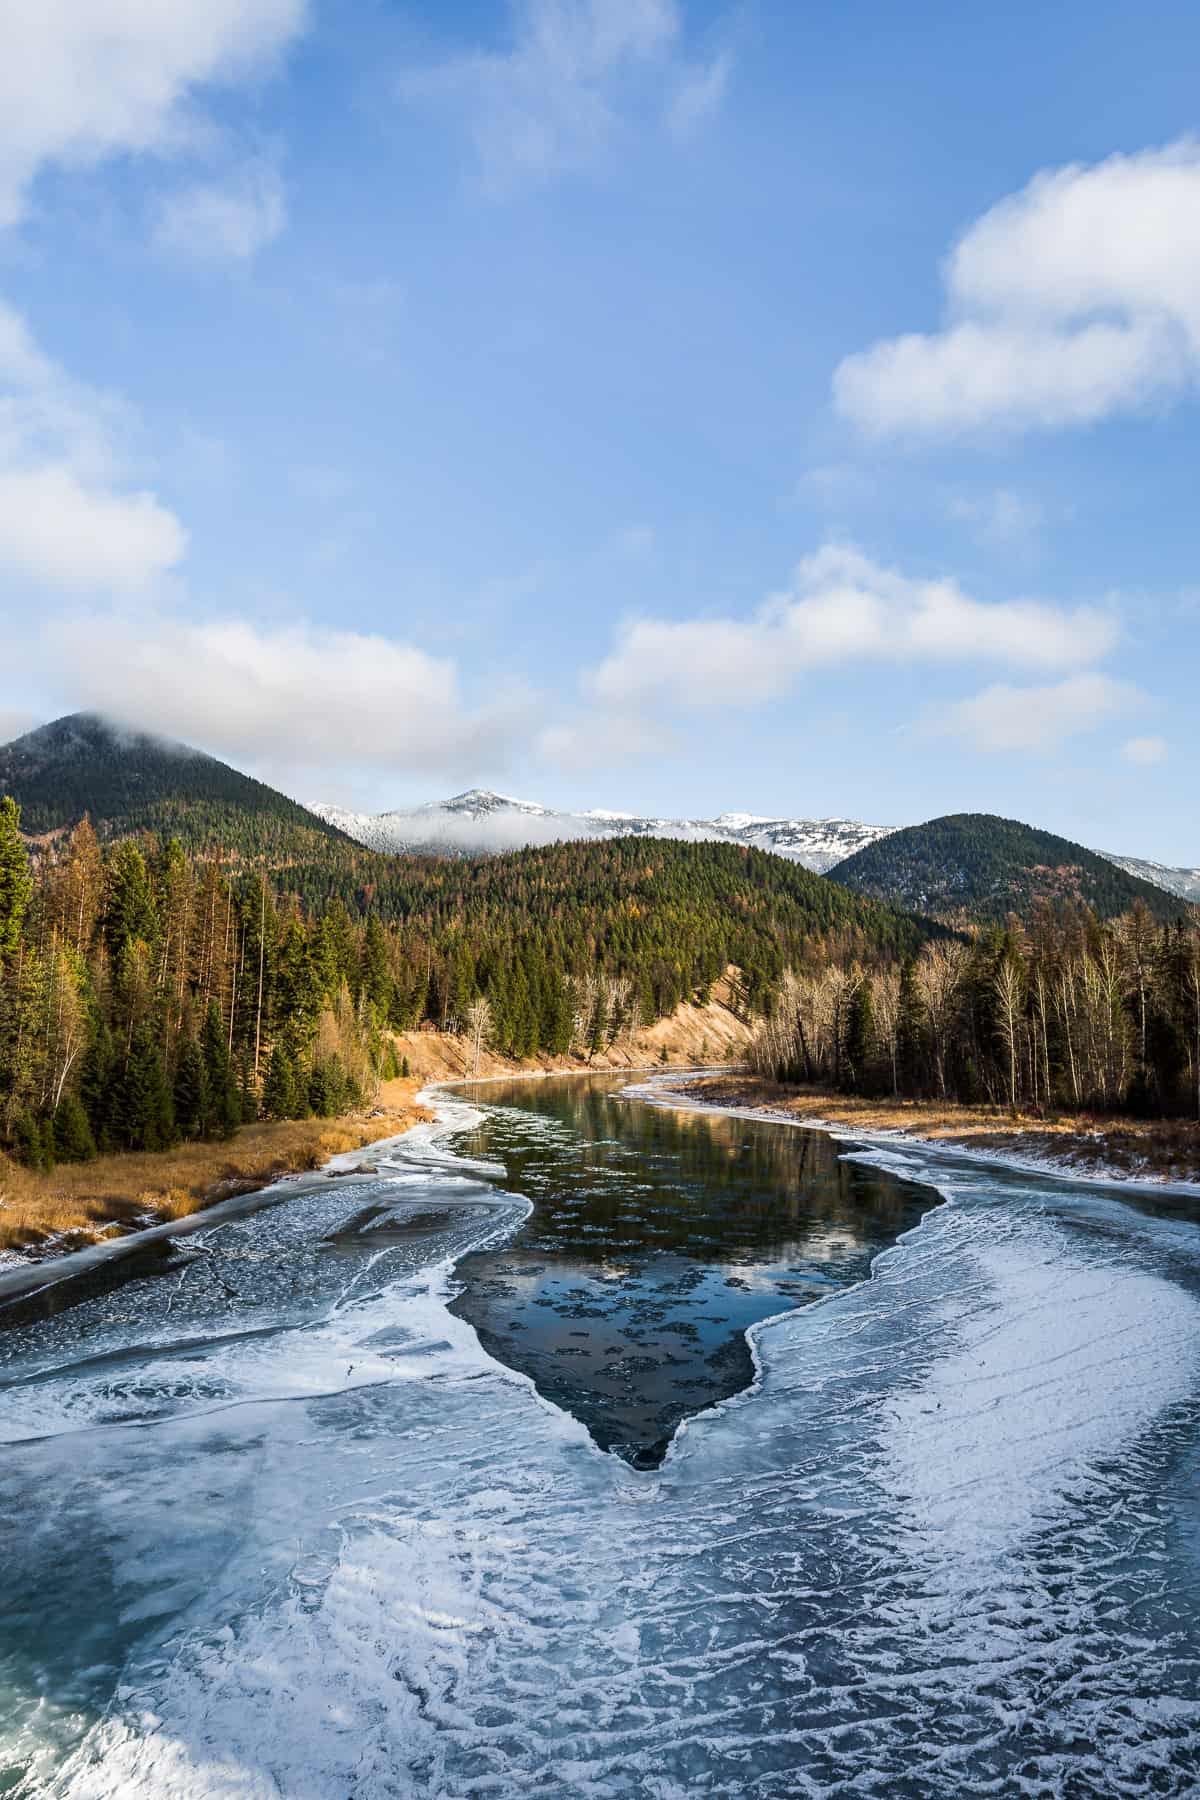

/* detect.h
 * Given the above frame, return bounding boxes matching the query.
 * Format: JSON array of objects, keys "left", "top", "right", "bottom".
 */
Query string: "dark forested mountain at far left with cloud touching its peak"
[{"left": 0, "top": 713, "right": 347, "bottom": 860}]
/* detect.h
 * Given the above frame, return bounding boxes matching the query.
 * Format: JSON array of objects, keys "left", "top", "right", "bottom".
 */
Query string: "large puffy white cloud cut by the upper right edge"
[{"left": 833, "top": 139, "right": 1200, "bottom": 436}]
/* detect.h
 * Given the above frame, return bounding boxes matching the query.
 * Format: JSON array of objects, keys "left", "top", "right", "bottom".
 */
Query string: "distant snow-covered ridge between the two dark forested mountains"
[{"left": 311, "top": 788, "right": 891, "bottom": 873}]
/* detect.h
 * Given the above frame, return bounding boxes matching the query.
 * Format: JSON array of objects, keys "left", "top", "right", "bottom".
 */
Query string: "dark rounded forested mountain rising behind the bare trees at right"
[{"left": 828, "top": 812, "right": 1182, "bottom": 920}]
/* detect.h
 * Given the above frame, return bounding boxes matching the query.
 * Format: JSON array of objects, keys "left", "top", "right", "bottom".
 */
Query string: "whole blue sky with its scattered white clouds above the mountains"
[{"left": 0, "top": 0, "right": 1200, "bottom": 862}]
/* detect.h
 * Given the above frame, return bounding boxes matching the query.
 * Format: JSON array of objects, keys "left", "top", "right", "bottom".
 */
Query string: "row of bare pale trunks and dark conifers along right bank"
[{"left": 754, "top": 902, "right": 1200, "bottom": 1118}]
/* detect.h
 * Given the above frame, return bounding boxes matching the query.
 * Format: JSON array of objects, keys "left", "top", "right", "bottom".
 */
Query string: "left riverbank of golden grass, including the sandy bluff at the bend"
[{"left": 0, "top": 983, "right": 748, "bottom": 1267}]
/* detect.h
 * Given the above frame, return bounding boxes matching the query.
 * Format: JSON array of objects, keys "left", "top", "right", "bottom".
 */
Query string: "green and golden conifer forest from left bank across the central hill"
[{"left": 0, "top": 799, "right": 923, "bottom": 1165}]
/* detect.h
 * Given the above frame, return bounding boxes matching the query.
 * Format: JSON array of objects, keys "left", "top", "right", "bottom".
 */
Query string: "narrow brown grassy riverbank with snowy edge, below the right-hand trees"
[{"left": 671, "top": 1073, "right": 1200, "bottom": 1184}]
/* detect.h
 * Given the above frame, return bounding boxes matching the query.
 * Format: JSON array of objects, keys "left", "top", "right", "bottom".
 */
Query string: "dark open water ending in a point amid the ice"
[{"left": 452, "top": 1076, "right": 936, "bottom": 1467}]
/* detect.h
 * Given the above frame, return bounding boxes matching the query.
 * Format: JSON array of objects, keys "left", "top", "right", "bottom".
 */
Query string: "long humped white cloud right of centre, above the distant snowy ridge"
[{"left": 590, "top": 545, "right": 1117, "bottom": 711}]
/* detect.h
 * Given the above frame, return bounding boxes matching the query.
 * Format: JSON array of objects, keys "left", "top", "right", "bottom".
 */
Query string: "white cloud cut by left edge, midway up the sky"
[{"left": 0, "top": 302, "right": 187, "bottom": 590}]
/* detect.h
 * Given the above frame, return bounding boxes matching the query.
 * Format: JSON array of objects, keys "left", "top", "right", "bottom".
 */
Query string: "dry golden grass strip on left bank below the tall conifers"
[{"left": 0, "top": 1082, "right": 428, "bottom": 1249}]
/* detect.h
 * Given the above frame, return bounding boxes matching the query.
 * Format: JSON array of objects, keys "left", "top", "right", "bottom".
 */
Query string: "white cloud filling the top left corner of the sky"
[{"left": 0, "top": 0, "right": 308, "bottom": 225}]
